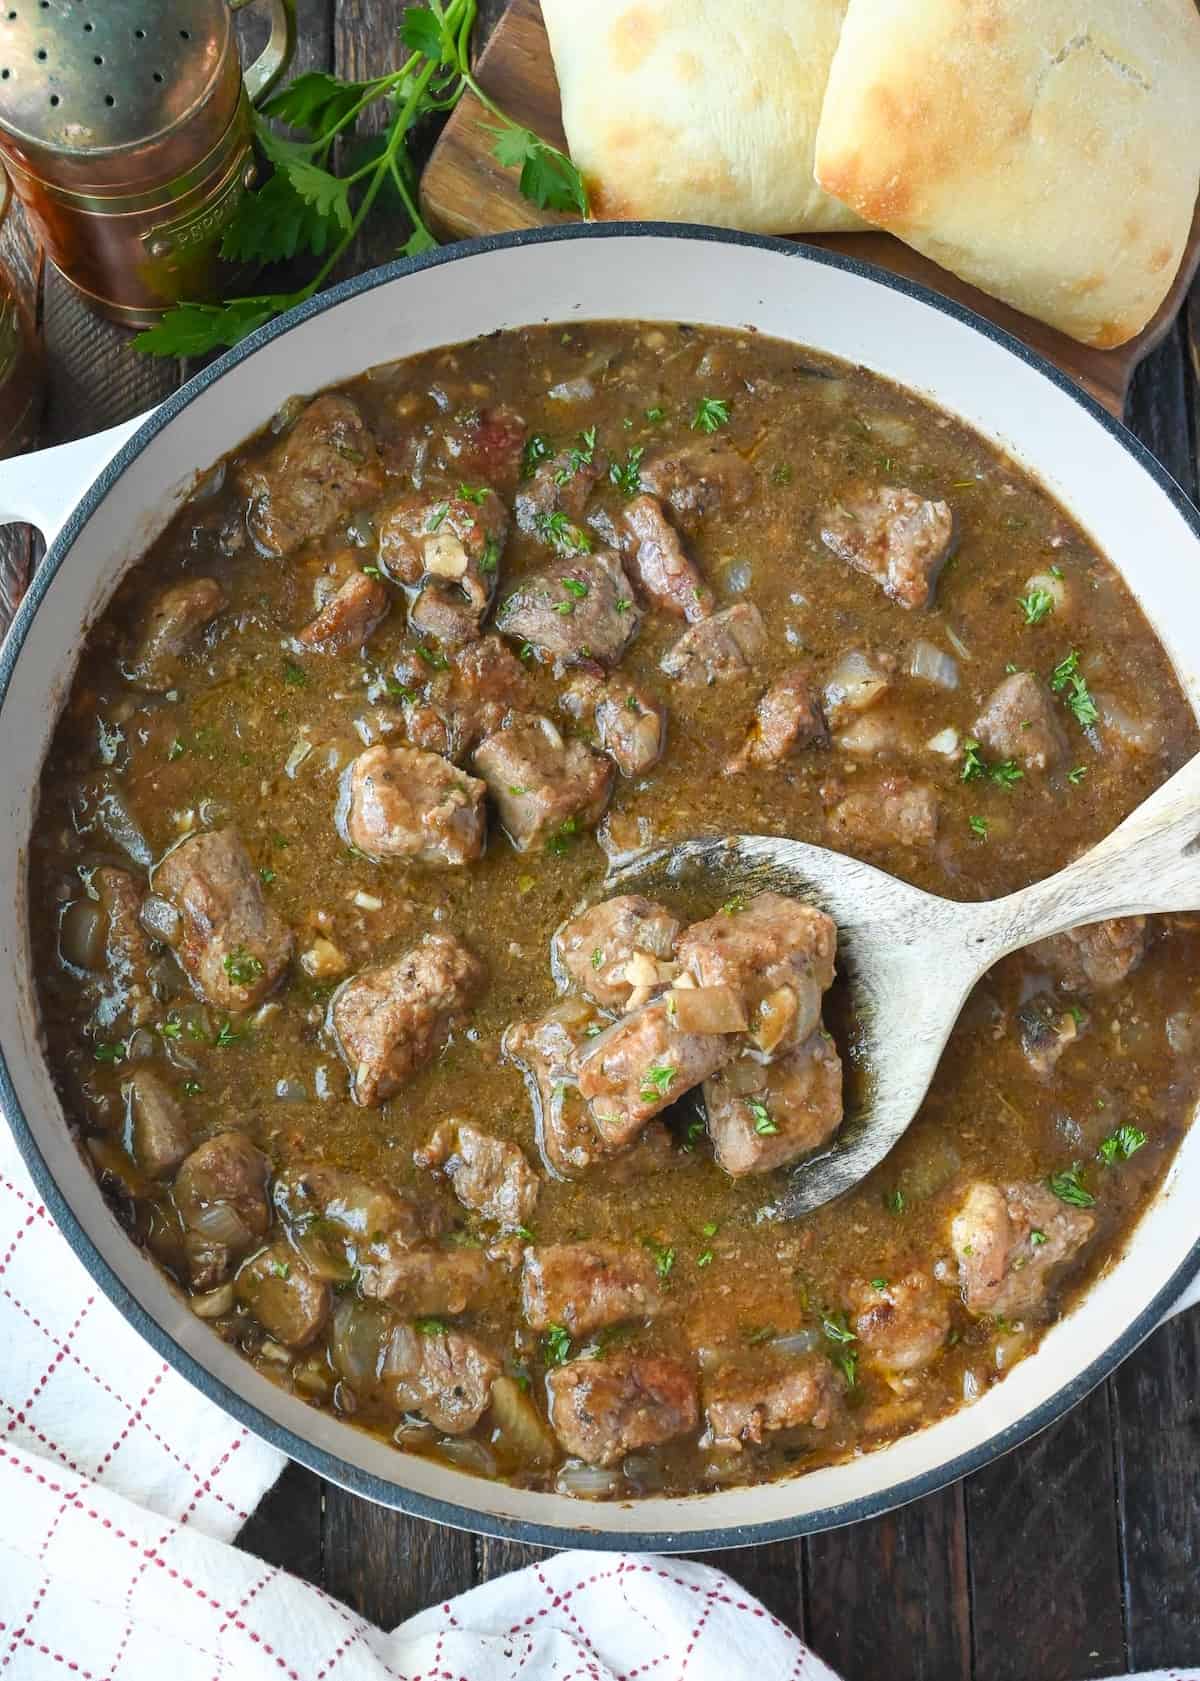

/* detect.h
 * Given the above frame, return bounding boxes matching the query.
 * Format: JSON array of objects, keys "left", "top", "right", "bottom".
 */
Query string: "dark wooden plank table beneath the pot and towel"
[{"left": 0, "top": 0, "right": 1200, "bottom": 1681}]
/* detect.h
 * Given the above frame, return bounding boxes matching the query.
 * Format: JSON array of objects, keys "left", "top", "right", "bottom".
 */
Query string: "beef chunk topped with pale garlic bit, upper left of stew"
[{"left": 380, "top": 486, "right": 509, "bottom": 646}]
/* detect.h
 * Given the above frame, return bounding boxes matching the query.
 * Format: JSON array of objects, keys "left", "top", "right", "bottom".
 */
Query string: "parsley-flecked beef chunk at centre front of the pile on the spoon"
[{"left": 580, "top": 993, "right": 738, "bottom": 1145}]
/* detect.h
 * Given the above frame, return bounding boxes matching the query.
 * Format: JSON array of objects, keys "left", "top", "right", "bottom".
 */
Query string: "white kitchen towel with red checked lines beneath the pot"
[{"left": 0, "top": 1123, "right": 1200, "bottom": 1681}]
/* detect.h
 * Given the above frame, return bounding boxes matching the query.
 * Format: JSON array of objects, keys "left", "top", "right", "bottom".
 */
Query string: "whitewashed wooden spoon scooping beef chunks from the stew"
[{"left": 605, "top": 755, "right": 1200, "bottom": 1217}]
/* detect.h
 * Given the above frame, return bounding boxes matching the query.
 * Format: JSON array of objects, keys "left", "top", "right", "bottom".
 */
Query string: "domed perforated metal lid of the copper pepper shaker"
[{"left": 0, "top": 0, "right": 237, "bottom": 160}]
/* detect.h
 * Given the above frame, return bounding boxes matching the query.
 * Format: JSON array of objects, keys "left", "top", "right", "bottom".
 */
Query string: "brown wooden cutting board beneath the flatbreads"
[{"left": 420, "top": 0, "right": 1200, "bottom": 415}]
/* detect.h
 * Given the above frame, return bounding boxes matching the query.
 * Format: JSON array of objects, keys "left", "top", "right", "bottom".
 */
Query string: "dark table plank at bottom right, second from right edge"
[{"left": 966, "top": 1387, "right": 1128, "bottom": 1681}]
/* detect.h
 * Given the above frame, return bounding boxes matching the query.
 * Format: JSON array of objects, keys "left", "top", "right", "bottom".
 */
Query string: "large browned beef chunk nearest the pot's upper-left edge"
[{"left": 237, "top": 392, "right": 383, "bottom": 555}]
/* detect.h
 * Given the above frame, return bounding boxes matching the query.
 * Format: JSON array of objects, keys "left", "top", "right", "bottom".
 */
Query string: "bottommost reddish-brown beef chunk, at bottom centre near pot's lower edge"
[{"left": 546, "top": 1353, "right": 699, "bottom": 1466}]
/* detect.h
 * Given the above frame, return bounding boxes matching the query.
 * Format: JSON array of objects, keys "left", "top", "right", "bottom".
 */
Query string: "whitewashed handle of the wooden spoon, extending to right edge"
[{"left": 973, "top": 755, "right": 1200, "bottom": 962}]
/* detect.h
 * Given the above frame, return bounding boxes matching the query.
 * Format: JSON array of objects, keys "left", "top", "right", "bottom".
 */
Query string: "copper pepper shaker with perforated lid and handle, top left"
[{"left": 0, "top": 0, "right": 294, "bottom": 326}]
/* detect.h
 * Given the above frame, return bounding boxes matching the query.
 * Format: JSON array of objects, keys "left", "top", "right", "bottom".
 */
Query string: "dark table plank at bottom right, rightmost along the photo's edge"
[{"left": 1111, "top": 1309, "right": 1200, "bottom": 1669}]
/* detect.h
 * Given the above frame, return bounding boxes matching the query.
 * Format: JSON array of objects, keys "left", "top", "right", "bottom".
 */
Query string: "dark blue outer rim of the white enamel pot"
[{"left": 0, "top": 222, "right": 1200, "bottom": 1552}]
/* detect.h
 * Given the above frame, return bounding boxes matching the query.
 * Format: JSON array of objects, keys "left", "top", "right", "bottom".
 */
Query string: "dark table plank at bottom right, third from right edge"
[{"left": 805, "top": 1484, "right": 971, "bottom": 1681}]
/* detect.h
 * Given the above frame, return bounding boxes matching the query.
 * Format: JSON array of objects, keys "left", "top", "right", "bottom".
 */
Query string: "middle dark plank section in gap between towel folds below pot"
[{"left": 321, "top": 1483, "right": 476, "bottom": 1629}]
